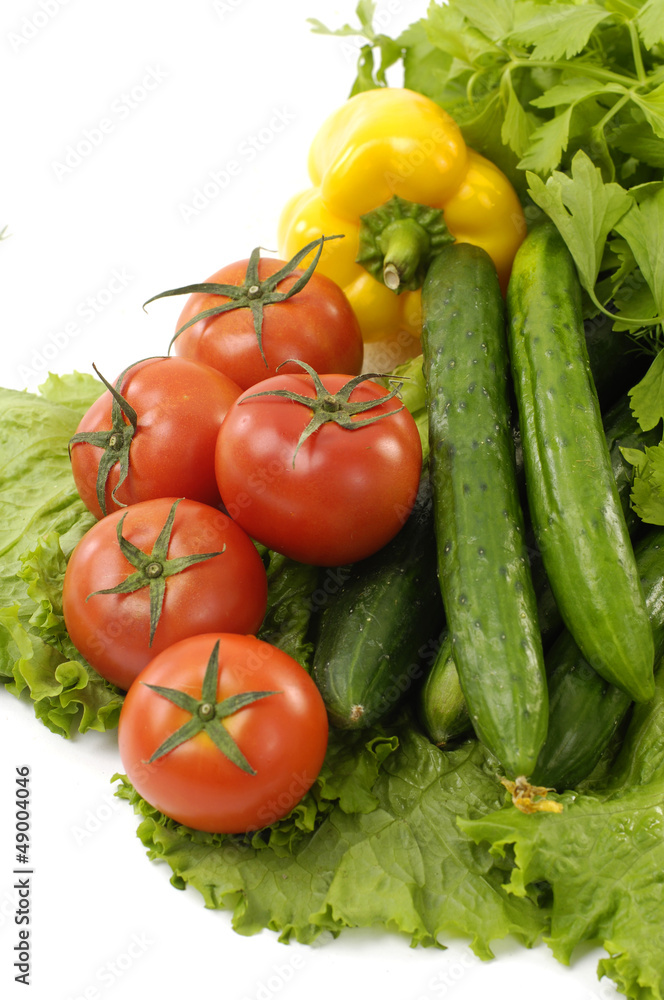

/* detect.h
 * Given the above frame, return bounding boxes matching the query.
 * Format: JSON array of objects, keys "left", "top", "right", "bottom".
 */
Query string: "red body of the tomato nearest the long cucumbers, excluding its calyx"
[{"left": 216, "top": 374, "right": 422, "bottom": 566}]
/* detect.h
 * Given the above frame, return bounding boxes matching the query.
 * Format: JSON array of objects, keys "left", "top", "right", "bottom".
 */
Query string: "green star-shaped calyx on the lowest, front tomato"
[{"left": 141, "top": 640, "right": 281, "bottom": 774}]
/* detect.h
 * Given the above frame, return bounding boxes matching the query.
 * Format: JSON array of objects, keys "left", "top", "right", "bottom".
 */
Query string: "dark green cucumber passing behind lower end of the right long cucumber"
[{"left": 532, "top": 528, "right": 664, "bottom": 791}]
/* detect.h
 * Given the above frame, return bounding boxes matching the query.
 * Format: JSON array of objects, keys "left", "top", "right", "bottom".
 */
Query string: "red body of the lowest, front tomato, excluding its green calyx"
[{"left": 118, "top": 633, "right": 328, "bottom": 833}]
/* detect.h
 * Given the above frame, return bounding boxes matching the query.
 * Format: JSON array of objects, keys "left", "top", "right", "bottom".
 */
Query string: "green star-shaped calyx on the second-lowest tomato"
[{"left": 86, "top": 497, "right": 226, "bottom": 646}]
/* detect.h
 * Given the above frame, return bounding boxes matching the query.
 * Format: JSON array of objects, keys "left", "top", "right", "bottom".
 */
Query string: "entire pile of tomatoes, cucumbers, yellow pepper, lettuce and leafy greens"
[{"left": 0, "top": 0, "right": 664, "bottom": 1000}]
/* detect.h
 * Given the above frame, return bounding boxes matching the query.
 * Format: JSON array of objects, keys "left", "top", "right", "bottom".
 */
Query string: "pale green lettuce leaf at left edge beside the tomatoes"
[{"left": 0, "top": 373, "right": 121, "bottom": 736}]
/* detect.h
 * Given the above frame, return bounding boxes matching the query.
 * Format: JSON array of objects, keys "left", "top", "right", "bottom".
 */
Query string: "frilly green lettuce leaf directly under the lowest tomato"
[{"left": 115, "top": 724, "right": 548, "bottom": 958}]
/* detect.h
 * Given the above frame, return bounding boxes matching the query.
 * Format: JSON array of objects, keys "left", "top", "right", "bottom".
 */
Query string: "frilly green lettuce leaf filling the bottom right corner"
[{"left": 459, "top": 780, "right": 664, "bottom": 1000}]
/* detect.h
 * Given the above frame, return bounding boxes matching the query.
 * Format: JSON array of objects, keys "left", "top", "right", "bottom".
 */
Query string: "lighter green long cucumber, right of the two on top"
[{"left": 507, "top": 224, "right": 654, "bottom": 701}]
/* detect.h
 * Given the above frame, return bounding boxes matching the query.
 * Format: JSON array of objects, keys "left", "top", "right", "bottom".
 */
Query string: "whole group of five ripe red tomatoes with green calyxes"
[{"left": 63, "top": 244, "right": 422, "bottom": 833}]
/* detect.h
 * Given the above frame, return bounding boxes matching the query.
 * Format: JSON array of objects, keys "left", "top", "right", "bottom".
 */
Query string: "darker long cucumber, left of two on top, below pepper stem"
[{"left": 422, "top": 243, "right": 547, "bottom": 777}]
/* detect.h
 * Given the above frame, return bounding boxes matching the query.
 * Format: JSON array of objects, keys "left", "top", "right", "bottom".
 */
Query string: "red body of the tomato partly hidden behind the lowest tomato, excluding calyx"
[{"left": 62, "top": 497, "right": 267, "bottom": 690}]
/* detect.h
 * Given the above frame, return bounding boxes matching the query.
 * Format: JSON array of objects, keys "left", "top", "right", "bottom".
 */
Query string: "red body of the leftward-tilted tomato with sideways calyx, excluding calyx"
[{"left": 71, "top": 358, "right": 240, "bottom": 518}]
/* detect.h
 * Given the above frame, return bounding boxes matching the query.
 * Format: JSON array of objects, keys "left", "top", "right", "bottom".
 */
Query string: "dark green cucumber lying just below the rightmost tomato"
[{"left": 312, "top": 473, "right": 444, "bottom": 729}]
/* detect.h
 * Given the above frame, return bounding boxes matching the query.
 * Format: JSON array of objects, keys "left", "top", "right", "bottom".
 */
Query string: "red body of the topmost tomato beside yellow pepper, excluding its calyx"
[{"left": 173, "top": 251, "right": 364, "bottom": 389}]
